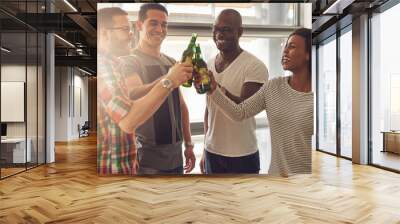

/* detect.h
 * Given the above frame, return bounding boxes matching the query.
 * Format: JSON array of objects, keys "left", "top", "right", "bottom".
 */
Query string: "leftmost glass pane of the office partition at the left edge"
[{"left": 0, "top": 32, "right": 27, "bottom": 177}]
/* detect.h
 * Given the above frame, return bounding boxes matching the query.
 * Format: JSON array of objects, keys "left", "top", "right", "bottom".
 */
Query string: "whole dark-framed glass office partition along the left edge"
[{"left": 0, "top": 1, "right": 46, "bottom": 178}]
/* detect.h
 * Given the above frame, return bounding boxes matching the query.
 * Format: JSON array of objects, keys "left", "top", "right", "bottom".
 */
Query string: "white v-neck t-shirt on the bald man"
[{"left": 205, "top": 51, "right": 268, "bottom": 157}]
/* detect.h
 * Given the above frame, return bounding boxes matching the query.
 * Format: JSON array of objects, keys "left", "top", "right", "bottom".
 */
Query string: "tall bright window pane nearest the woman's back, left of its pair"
[{"left": 317, "top": 36, "right": 336, "bottom": 154}]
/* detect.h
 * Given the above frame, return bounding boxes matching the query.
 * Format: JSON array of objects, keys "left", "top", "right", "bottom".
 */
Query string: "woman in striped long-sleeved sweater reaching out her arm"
[{"left": 209, "top": 28, "right": 314, "bottom": 177}]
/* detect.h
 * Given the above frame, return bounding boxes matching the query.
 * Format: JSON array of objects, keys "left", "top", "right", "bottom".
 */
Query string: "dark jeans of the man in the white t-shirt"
[{"left": 205, "top": 150, "right": 260, "bottom": 174}]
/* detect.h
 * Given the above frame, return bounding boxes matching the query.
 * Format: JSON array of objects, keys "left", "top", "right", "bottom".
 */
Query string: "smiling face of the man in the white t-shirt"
[{"left": 213, "top": 13, "right": 243, "bottom": 52}]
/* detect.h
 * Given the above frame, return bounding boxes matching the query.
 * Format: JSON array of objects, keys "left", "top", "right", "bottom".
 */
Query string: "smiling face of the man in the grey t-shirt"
[{"left": 137, "top": 9, "right": 168, "bottom": 47}]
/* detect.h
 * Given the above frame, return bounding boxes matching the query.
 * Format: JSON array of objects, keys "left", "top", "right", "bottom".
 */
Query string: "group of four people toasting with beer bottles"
[{"left": 98, "top": 3, "right": 313, "bottom": 176}]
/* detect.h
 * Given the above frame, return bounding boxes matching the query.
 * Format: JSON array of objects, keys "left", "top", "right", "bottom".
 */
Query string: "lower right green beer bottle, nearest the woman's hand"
[{"left": 193, "top": 44, "right": 211, "bottom": 94}]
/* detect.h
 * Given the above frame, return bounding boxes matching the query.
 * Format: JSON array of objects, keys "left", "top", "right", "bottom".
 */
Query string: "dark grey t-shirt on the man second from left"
[{"left": 121, "top": 49, "right": 183, "bottom": 170}]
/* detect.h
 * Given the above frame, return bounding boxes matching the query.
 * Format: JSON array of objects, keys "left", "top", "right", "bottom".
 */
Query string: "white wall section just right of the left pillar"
[{"left": 55, "top": 67, "right": 88, "bottom": 141}]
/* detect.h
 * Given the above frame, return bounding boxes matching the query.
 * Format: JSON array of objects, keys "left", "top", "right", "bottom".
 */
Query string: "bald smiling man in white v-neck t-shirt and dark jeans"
[{"left": 200, "top": 9, "right": 268, "bottom": 174}]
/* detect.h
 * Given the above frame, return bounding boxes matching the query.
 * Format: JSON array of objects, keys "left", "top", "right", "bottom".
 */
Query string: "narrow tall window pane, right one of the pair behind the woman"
[{"left": 340, "top": 27, "right": 353, "bottom": 158}]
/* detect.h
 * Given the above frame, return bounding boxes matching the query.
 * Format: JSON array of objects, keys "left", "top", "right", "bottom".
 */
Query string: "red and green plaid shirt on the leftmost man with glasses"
[{"left": 97, "top": 54, "right": 136, "bottom": 175}]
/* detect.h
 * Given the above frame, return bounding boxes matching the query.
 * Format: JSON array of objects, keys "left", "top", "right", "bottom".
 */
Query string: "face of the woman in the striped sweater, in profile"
[{"left": 281, "top": 35, "right": 310, "bottom": 72}]
